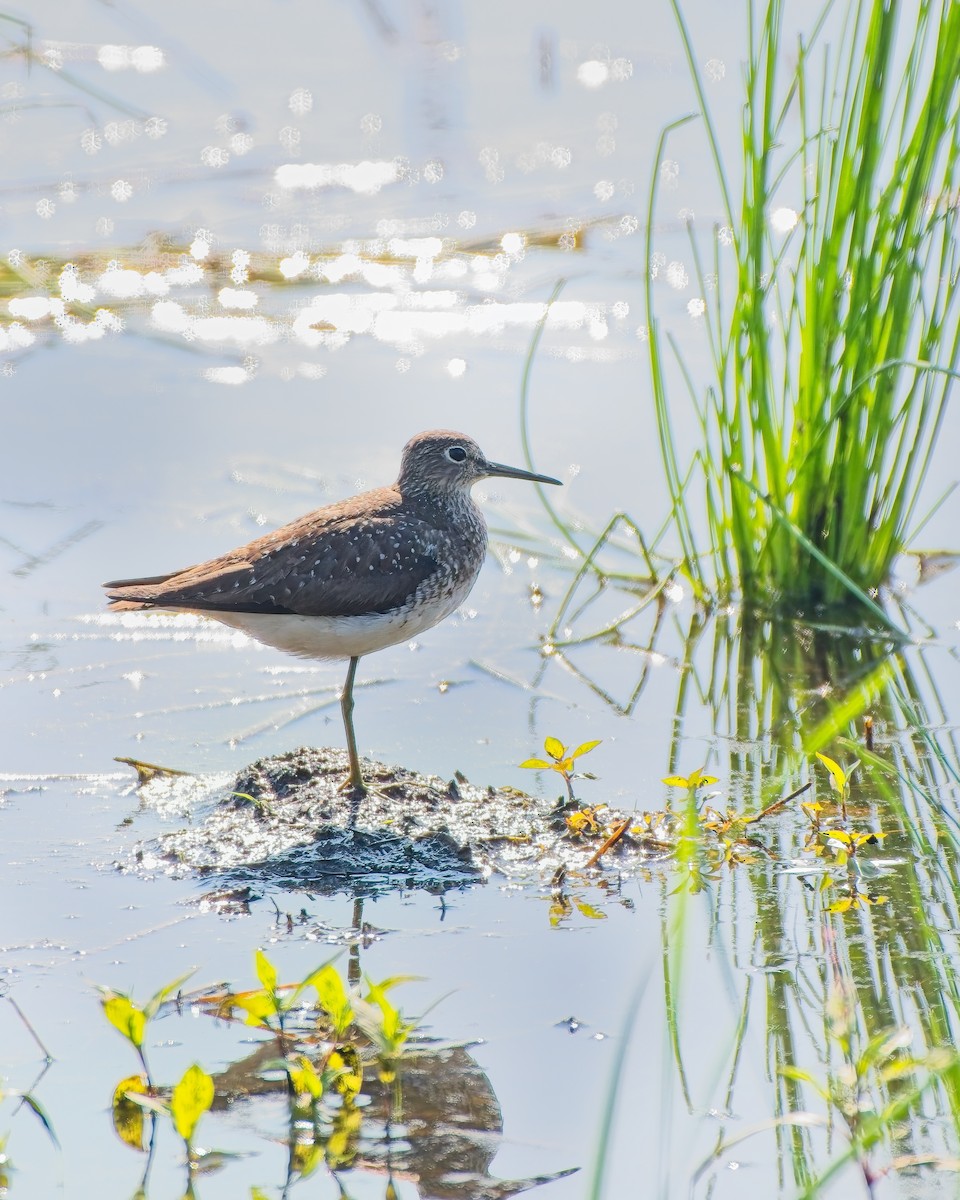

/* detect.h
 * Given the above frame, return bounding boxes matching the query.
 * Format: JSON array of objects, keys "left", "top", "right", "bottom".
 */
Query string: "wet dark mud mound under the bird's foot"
[{"left": 129, "top": 748, "right": 649, "bottom": 895}]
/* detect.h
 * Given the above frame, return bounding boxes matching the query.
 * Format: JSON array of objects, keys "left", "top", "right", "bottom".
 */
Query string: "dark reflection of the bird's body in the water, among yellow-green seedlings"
[{"left": 104, "top": 900, "right": 576, "bottom": 1200}]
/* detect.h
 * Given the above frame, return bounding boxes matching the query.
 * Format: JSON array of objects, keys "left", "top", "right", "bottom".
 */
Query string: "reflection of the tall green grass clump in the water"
[{"left": 538, "top": 581, "right": 960, "bottom": 1195}]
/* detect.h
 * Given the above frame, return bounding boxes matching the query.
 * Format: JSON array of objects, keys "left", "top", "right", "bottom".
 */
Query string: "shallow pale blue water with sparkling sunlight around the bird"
[{"left": 0, "top": 0, "right": 960, "bottom": 1200}]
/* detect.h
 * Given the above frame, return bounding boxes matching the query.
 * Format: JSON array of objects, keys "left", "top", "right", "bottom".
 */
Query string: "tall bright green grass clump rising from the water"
[{"left": 647, "top": 0, "right": 960, "bottom": 616}]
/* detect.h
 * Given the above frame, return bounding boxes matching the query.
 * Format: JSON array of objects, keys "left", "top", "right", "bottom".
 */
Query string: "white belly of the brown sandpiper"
[{"left": 200, "top": 581, "right": 473, "bottom": 659}]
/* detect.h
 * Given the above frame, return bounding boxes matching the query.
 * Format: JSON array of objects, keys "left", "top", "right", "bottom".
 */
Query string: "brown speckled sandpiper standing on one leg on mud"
[{"left": 103, "top": 430, "right": 562, "bottom": 796}]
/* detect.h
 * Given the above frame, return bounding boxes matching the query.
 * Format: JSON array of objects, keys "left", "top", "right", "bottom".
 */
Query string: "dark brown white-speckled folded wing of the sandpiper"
[{"left": 104, "top": 510, "right": 444, "bottom": 617}]
